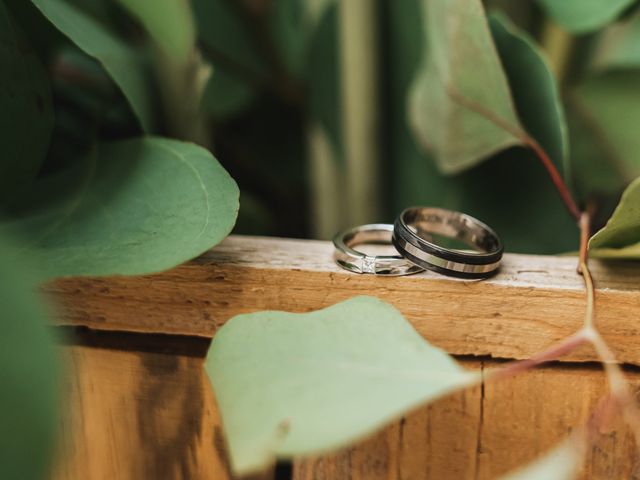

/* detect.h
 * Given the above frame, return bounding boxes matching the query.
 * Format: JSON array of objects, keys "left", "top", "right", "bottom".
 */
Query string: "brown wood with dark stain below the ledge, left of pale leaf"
[{"left": 52, "top": 346, "right": 230, "bottom": 480}]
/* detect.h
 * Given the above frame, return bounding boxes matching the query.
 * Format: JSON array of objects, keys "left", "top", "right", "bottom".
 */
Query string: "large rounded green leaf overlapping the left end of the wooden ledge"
[{"left": 1, "top": 137, "right": 238, "bottom": 277}]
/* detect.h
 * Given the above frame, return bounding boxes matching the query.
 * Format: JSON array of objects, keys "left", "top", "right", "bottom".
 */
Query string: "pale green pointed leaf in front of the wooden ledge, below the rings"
[{"left": 206, "top": 297, "right": 479, "bottom": 475}]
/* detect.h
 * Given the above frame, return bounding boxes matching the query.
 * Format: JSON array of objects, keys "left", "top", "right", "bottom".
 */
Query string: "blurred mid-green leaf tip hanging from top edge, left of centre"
[{"left": 119, "top": 0, "right": 196, "bottom": 62}]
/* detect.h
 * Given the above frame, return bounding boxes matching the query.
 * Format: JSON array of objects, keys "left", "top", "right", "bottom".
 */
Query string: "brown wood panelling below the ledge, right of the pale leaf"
[{"left": 294, "top": 361, "right": 640, "bottom": 480}]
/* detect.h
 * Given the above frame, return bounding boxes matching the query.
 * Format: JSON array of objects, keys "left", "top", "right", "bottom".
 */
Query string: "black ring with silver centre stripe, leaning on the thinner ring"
[{"left": 392, "top": 207, "right": 503, "bottom": 278}]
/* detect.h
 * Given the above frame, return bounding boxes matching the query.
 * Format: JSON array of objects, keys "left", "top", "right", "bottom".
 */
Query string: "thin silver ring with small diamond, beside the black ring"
[{"left": 333, "top": 223, "right": 423, "bottom": 275}]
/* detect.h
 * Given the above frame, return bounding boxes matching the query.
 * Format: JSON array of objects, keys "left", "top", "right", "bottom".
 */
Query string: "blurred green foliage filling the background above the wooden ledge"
[{"left": 6, "top": 0, "right": 640, "bottom": 472}]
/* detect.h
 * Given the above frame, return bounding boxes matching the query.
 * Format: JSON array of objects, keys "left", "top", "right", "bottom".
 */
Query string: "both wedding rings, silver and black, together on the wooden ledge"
[{"left": 333, "top": 207, "right": 503, "bottom": 278}]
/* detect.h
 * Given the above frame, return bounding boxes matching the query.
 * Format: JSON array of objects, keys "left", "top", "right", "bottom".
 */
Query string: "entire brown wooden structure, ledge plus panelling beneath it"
[{"left": 46, "top": 237, "right": 640, "bottom": 480}]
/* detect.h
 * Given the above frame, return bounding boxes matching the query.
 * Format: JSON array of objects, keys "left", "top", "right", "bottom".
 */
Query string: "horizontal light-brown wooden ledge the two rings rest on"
[{"left": 45, "top": 236, "right": 640, "bottom": 365}]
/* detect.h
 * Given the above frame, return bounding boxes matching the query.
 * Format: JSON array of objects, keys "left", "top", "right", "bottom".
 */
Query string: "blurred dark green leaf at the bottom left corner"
[{"left": 0, "top": 239, "right": 60, "bottom": 479}]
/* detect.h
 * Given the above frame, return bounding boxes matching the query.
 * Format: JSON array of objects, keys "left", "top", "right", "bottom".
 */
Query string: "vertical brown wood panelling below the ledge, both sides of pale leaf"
[{"left": 52, "top": 334, "right": 640, "bottom": 480}]
